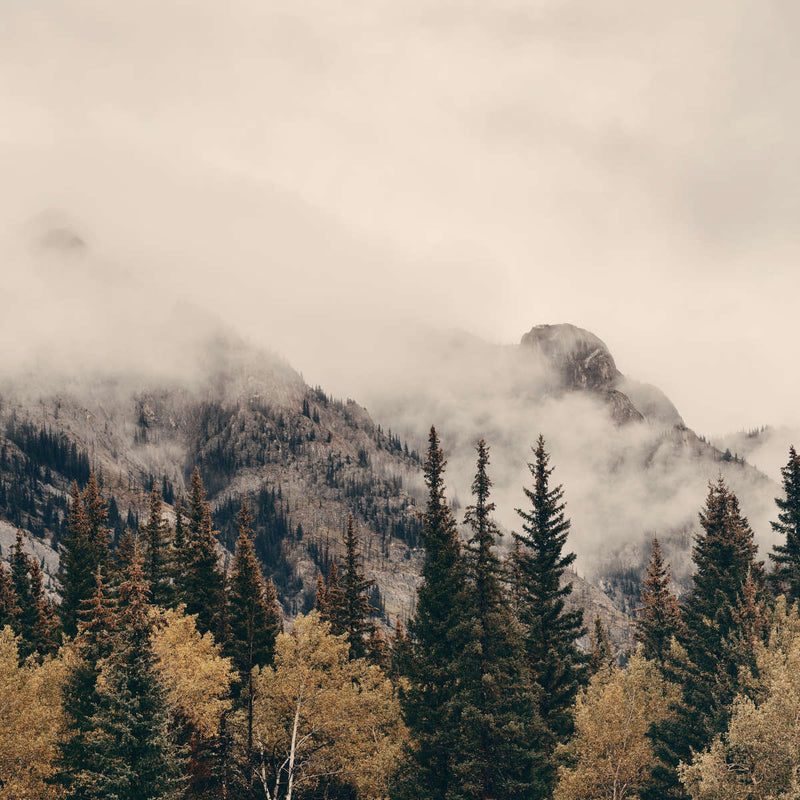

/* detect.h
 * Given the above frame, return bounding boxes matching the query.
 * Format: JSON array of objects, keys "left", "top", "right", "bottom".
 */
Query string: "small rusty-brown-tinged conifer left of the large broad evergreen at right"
[{"left": 635, "top": 537, "right": 681, "bottom": 666}]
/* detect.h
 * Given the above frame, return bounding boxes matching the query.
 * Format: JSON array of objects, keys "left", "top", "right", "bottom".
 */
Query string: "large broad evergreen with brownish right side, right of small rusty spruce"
[{"left": 648, "top": 478, "right": 765, "bottom": 798}]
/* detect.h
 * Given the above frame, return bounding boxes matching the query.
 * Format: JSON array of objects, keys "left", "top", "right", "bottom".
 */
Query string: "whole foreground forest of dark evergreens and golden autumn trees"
[{"left": 0, "top": 428, "right": 800, "bottom": 800}]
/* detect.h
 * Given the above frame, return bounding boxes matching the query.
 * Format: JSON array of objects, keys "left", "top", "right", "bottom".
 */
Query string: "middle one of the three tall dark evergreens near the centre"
[{"left": 447, "top": 440, "right": 551, "bottom": 800}]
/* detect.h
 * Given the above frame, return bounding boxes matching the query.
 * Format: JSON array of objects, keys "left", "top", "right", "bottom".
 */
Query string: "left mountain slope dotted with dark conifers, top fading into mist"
[{"left": 0, "top": 336, "right": 421, "bottom": 618}]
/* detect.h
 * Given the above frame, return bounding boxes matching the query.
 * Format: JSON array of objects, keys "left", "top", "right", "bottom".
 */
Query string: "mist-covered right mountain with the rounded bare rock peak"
[{"left": 362, "top": 324, "right": 789, "bottom": 611}]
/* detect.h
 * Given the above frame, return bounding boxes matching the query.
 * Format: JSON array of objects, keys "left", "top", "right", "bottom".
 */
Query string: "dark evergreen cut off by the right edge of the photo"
[{"left": 769, "top": 447, "right": 800, "bottom": 603}]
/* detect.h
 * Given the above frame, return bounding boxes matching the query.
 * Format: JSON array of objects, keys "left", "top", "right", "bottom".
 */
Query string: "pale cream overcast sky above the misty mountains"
[{"left": 0, "top": 0, "right": 800, "bottom": 433}]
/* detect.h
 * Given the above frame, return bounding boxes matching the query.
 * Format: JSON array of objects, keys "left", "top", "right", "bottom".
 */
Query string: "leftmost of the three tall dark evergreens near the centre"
[{"left": 396, "top": 428, "right": 465, "bottom": 800}]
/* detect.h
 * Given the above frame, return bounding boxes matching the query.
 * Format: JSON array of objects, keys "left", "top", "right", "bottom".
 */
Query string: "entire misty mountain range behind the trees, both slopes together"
[{"left": 0, "top": 309, "right": 777, "bottom": 646}]
